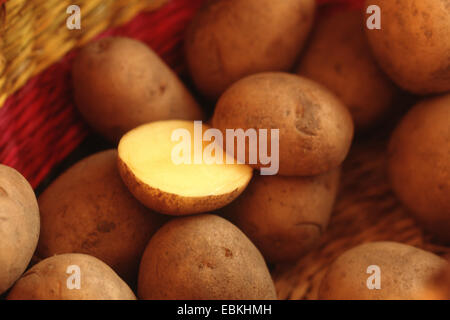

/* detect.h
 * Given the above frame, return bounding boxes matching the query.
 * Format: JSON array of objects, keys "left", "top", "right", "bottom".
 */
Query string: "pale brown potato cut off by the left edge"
[{"left": 0, "top": 164, "right": 40, "bottom": 295}]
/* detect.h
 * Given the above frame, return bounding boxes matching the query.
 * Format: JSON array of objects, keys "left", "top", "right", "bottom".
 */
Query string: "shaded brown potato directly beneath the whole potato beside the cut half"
[{"left": 223, "top": 168, "right": 340, "bottom": 263}]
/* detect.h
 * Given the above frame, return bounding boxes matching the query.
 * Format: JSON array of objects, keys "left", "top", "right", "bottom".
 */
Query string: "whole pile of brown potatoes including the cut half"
[{"left": 0, "top": 0, "right": 450, "bottom": 300}]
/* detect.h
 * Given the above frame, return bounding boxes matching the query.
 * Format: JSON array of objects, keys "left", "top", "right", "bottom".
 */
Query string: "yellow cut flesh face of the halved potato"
[{"left": 119, "top": 120, "right": 252, "bottom": 197}]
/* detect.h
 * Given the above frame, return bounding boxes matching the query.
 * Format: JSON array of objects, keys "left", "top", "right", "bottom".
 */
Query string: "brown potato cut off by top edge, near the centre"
[{"left": 185, "top": 0, "right": 316, "bottom": 99}]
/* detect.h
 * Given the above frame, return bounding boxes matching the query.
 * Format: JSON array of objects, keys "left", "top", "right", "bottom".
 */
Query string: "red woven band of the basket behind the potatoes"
[{"left": 0, "top": 0, "right": 363, "bottom": 187}]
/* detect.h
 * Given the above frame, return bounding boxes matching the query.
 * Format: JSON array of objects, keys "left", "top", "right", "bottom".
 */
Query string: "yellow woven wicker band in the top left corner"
[{"left": 0, "top": 0, "right": 167, "bottom": 106}]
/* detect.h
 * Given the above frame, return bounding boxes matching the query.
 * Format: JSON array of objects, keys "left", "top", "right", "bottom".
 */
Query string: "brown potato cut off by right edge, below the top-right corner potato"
[{"left": 388, "top": 94, "right": 450, "bottom": 244}]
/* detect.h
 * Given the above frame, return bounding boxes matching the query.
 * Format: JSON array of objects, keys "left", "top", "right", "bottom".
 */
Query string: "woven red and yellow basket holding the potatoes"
[{"left": 0, "top": 0, "right": 450, "bottom": 299}]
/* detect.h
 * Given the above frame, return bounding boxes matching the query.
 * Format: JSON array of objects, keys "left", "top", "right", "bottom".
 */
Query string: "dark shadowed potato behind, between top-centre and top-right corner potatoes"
[{"left": 297, "top": 10, "right": 397, "bottom": 130}]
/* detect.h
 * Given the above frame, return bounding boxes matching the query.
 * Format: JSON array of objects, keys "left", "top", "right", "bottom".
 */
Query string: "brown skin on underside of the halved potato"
[{"left": 118, "top": 157, "right": 250, "bottom": 216}]
